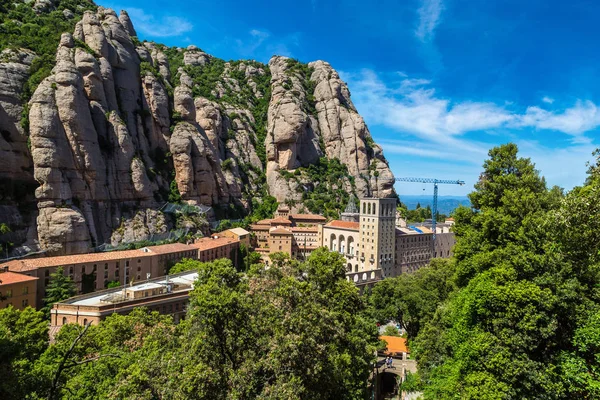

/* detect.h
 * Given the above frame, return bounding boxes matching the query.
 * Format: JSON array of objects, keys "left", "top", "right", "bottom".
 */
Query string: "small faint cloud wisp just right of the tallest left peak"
[{"left": 127, "top": 8, "right": 194, "bottom": 37}]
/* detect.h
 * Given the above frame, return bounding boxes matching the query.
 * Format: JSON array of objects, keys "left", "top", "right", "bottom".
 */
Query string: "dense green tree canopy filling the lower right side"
[{"left": 370, "top": 144, "right": 600, "bottom": 399}]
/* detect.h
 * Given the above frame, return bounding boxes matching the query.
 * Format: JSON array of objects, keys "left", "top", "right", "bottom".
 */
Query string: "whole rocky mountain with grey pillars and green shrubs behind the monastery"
[{"left": 0, "top": 0, "right": 395, "bottom": 254}]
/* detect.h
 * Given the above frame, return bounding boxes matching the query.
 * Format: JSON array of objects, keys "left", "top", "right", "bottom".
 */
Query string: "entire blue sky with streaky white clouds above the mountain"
[{"left": 99, "top": 0, "right": 600, "bottom": 195}]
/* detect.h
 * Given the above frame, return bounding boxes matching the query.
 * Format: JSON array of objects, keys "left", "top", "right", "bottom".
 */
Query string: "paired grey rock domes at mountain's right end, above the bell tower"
[{"left": 265, "top": 57, "right": 394, "bottom": 202}]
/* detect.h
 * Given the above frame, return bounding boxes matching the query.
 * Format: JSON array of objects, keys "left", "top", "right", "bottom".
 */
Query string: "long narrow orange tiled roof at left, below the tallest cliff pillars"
[{"left": 0, "top": 247, "right": 153, "bottom": 272}]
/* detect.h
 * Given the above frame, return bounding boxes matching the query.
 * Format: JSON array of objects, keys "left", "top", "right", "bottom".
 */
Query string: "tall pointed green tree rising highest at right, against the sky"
[{"left": 412, "top": 144, "right": 572, "bottom": 399}]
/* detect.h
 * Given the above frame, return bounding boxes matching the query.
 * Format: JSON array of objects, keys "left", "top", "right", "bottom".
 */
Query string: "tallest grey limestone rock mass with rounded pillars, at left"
[{"left": 30, "top": 7, "right": 170, "bottom": 253}]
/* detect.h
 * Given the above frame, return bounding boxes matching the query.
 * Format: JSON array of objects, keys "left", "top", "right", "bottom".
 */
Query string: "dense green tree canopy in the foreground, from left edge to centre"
[{"left": 0, "top": 248, "right": 378, "bottom": 400}]
